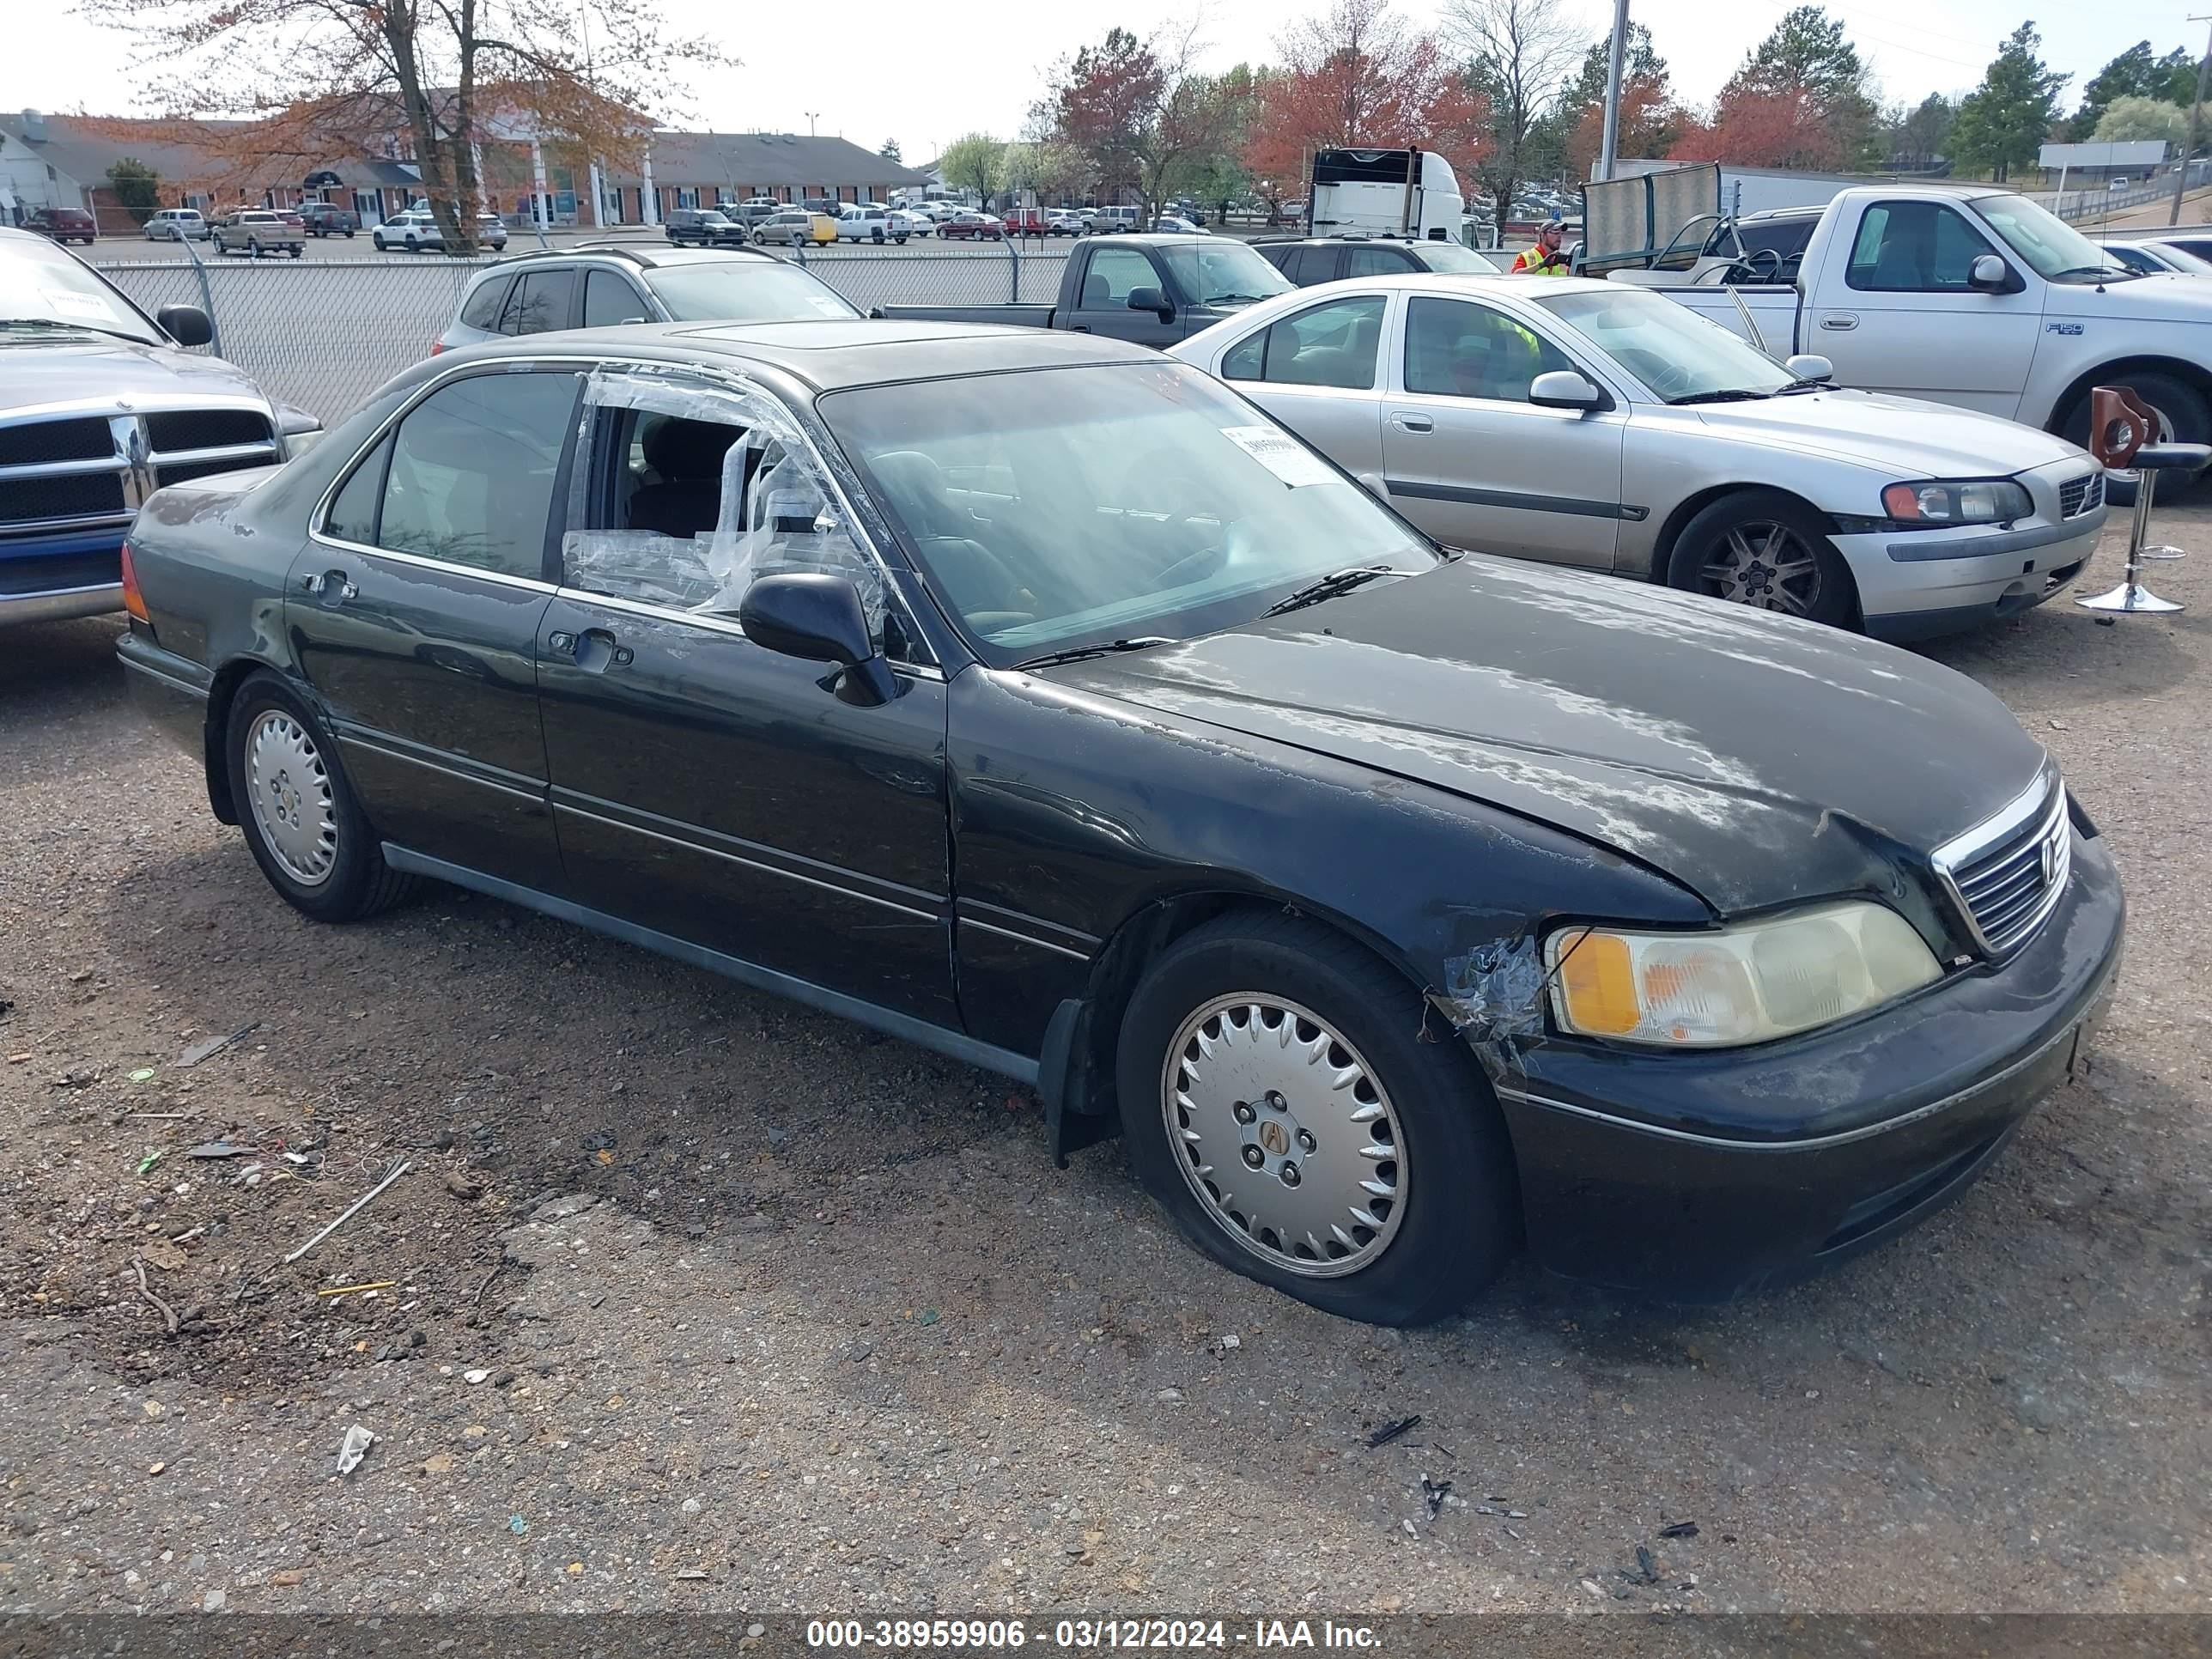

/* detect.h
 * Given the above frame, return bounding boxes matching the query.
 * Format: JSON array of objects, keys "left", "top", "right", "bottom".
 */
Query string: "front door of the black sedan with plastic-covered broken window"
[{"left": 540, "top": 372, "right": 960, "bottom": 1029}]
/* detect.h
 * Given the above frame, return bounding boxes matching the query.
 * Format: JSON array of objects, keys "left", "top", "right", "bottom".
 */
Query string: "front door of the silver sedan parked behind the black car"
[{"left": 1382, "top": 295, "right": 1626, "bottom": 571}]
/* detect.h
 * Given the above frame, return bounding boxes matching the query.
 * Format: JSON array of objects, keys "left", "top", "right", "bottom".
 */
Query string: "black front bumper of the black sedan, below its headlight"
[{"left": 1474, "top": 838, "right": 2124, "bottom": 1301}]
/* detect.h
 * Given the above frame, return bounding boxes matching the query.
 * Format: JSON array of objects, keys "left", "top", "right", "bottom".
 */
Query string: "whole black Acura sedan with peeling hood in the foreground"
[{"left": 122, "top": 321, "right": 2124, "bottom": 1322}]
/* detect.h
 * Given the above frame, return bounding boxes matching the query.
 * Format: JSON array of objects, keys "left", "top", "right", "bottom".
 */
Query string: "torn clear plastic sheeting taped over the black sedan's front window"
[{"left": 562, "top": 369, "right": 884, "bottom": 629}]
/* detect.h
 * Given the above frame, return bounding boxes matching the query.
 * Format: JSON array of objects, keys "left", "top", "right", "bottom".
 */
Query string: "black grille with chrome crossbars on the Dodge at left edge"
[{"left": 0, "top": 404, "right": 283, "bottom": 540}]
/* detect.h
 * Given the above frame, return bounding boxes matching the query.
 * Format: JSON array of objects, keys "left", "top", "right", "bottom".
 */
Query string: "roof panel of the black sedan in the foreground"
[{"left": 438, "top": 319, "right": 1161, "bottom": 392}]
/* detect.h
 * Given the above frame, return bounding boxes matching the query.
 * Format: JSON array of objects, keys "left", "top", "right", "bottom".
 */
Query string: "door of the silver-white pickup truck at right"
[{"left": 1798, "top": 199, "right": 2042, "bottom": 420}]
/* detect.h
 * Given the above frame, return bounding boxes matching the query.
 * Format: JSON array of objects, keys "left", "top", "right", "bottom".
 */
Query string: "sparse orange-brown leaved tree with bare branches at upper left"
[{"left": 77, "top": 0, "right": 728, "bottom": 254}]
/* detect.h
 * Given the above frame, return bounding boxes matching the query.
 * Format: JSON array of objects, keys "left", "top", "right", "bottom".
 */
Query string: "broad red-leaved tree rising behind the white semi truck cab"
[{"left": 1243, "top": 0, "right": 1491, "bottom": 201}]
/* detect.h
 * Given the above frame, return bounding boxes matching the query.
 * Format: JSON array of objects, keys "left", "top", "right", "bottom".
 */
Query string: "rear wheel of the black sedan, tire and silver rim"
[{"left": 223, "top": 672, "right": 416, "bottom": 922}]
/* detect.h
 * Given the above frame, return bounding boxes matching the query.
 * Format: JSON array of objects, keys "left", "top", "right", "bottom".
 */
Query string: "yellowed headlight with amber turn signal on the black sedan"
[{"left": 1544, "top": 900, "right": 1942, "bottom": 1048}]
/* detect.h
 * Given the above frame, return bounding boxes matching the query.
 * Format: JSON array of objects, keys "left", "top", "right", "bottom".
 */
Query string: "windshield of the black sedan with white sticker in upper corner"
[{"left": 821, "top": 362, "right": 1437, "bottom": 668}]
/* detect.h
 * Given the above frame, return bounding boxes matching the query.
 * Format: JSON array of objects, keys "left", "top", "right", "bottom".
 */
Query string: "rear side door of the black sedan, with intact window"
[{"left": 285, "top": 365, "right": 581, "bottom": 887}]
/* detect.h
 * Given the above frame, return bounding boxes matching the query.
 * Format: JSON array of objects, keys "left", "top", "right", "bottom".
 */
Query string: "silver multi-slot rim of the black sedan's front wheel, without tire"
[{"left": 1159, "top": 991, "right": 1409, "bottom": 1279}]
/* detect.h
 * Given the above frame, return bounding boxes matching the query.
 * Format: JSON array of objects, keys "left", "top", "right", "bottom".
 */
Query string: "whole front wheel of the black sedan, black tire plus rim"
[{"left": 1115, "top": 911, "right": 1520, "bottom": 1325}]
